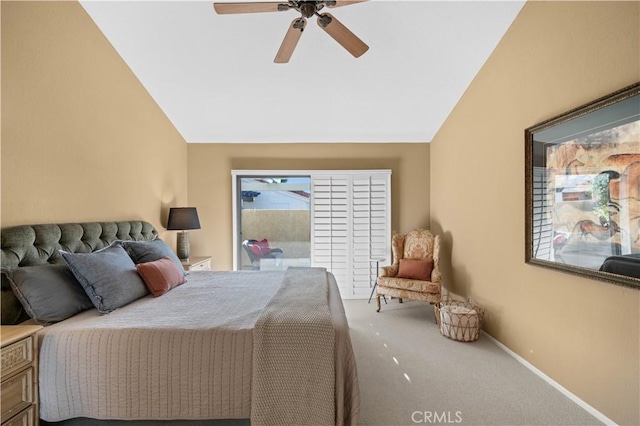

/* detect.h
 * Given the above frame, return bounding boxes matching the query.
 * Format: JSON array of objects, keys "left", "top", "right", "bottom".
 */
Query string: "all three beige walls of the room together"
[{"left": 1, "top": 1, "right": 640, "bottom": 424}]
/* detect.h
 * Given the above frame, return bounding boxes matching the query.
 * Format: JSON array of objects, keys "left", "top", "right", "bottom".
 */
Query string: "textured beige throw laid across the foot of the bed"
[{"left": 251, "top": 268, "right": 335, "bottom": 426}]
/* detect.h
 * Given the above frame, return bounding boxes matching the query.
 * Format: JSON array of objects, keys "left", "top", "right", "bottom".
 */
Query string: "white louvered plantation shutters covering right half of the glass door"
[{"left": 311, "top": 171, "right": 391, "bottom": 298}]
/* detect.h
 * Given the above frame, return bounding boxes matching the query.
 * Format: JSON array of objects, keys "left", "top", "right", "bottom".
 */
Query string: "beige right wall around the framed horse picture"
[{"left": 431, "top": 2, "right": 640, "bottom": 425}]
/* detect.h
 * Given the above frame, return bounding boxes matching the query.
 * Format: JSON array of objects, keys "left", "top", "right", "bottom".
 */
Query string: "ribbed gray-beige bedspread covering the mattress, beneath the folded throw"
[{"left": 39, "top": 271, "right": 359, "bottom": 424}]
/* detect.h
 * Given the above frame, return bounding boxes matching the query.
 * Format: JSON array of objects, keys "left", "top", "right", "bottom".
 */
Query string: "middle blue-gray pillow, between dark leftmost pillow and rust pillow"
[{"left": 60, "top": 242, "right": 149, "bottom": 314}]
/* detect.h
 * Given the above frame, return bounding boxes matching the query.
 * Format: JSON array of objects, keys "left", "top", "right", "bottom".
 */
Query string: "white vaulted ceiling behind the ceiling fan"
[{"left": 81, "top": 0, "right": 524, "bottom": 143}]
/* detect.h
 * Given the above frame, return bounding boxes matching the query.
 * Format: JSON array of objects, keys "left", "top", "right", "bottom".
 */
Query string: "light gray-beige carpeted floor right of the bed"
[{"left": 344, "top": 300, "right": 602, "bottom": 426}]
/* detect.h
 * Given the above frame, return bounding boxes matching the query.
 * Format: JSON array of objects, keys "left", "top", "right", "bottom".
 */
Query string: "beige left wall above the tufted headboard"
[{"left": 2, "top": 1, "right": 187, "bottom": 243}]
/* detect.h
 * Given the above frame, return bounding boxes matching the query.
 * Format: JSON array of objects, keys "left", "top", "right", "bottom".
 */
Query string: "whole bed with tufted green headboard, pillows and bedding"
[{"left": 1, "top": 221, "right": 360, "bottom": 425}]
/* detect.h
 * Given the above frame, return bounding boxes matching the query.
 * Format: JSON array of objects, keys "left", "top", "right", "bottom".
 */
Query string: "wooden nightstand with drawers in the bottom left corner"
[{"left": 0, "top": 325, "right": 42, "bottom": 426}]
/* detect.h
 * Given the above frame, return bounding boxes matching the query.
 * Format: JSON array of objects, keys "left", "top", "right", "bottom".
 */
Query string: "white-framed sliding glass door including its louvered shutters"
[{"left": 232, "top": 170, "right": 392, "bottom": 299}]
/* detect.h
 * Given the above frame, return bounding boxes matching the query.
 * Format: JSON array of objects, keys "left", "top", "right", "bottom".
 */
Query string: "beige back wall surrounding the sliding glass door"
[{"left": 188, "top": 144, "right": 429, "bottom": 270}]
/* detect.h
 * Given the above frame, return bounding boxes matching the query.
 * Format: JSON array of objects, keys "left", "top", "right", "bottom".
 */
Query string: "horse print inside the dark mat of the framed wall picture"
[{"left": 548, "top": 146, "right": 640, "bottom": 267}]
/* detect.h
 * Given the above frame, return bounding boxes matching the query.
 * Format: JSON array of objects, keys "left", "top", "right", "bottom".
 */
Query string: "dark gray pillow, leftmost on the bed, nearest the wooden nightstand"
[{"left": 5, "top": 265, "right": 93, "bottom": 325}]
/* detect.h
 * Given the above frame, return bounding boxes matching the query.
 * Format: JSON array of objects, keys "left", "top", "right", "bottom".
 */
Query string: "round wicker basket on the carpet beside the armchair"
[{"left": 433, "top": 300, "right": 484, "bottom": 342}]
